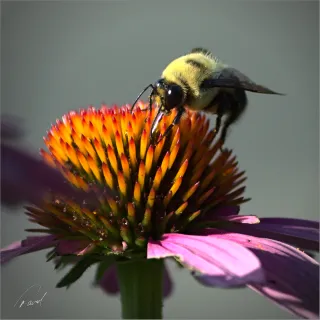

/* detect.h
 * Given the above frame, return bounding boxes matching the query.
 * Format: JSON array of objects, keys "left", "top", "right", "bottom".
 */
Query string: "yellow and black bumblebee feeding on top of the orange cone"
[{"left": 131, "top": 48, "right": 282, "bottom": 145}]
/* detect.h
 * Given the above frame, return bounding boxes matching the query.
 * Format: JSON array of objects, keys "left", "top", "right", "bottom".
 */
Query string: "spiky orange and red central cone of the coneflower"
[{"left": 28, "top": 107, "right": 246, "bottom": 256}]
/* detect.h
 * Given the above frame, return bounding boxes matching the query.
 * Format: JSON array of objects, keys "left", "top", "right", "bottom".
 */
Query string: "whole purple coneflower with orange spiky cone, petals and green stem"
[{"left": 1, "top": 102, "right": 319, "bottom": 318}]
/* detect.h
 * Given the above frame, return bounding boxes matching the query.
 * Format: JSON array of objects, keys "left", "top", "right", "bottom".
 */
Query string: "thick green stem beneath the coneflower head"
[{"left": 117, "top": 259, "right": 163, "bottom": 319}]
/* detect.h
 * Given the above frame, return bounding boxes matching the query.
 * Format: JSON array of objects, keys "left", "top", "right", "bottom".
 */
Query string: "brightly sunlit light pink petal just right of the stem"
[{"left": 147, "top": 233, "right": 265, "bottom": 288}]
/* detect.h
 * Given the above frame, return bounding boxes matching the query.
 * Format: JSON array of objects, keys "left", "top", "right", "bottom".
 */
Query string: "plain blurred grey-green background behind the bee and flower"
[{"left": 1, "top": 1, "right": 319, "bottom": 319}]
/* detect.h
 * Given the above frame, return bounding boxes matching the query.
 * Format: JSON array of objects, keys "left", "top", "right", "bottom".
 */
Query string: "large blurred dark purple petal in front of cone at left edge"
[{"left": 1, "top": 144, "right": 111, "bottom": 205}]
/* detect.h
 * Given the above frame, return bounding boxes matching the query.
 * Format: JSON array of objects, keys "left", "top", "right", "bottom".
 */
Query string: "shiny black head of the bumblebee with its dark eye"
[{"left": 153, "top": 79, "right": 185, "bottom": 111}]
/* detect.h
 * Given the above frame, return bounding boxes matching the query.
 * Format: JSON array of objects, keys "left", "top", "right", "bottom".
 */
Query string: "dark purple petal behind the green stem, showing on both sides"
[{"left": 99, "top": 265, "right": 173, "bottom": 298}]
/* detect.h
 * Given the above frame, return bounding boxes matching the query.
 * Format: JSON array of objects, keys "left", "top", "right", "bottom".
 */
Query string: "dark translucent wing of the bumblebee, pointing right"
[{"left": 201, "top": 67, "right": 283, "bottom": 95}]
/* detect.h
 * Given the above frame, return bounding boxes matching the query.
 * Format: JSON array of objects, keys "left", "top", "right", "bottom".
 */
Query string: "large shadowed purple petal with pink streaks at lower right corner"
[{"left": 200, "top": 229, "right": 319, "bottom": 319}]
